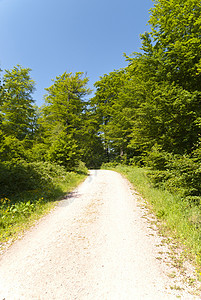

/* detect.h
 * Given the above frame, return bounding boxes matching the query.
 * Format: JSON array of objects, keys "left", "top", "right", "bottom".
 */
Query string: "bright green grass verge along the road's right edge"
[{"left": 105, "top": 165, "right": 201, "bottom": 273}]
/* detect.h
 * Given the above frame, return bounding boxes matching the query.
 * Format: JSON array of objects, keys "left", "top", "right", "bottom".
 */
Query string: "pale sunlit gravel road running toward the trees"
[{"left": 0, "top": 170, "right": 199, "bottom": 300}]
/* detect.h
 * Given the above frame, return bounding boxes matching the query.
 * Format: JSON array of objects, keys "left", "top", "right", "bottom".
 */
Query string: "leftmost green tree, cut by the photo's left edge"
[{"left": 0, "top": 65, "right": 35, "bottom": 140}]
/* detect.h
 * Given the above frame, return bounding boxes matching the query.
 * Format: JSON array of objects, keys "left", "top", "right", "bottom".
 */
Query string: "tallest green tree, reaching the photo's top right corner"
[{"left": 123, "top": 0, "right": 201, "bottom": 154}]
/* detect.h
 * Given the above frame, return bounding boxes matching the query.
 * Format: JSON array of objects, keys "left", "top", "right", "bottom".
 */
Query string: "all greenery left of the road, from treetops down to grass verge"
[{"left": 0, "top": 65, "right": 90, "bottom": 244}]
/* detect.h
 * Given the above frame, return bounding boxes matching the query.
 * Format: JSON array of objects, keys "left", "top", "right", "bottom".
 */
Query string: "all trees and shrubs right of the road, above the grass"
[{"left": 91, "top": 0, "right": 201, "bottom": 205}]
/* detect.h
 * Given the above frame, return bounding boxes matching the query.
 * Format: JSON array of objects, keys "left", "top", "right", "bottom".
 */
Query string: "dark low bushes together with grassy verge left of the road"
[{"left": 0, "top": 162, "right": 87, "bottom": 245}]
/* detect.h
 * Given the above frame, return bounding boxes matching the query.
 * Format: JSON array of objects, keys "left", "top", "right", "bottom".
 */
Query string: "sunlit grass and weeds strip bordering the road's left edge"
[{"left": 0, "top": 172, "right": 86, "bottom": 248}]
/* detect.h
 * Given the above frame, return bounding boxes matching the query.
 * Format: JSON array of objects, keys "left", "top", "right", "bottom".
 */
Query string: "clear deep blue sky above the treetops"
[{"left": 0, "top": 0, "right": 153, "bottom": 106}]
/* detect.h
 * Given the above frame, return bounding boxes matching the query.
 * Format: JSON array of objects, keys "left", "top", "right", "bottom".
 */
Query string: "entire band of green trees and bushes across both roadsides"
[{"left": 0, "top": 0, "right": 201, "bottom": 255}]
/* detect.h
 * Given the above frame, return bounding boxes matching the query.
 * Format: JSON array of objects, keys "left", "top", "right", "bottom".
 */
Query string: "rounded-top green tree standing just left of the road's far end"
[{"left": 41, "top": 72, "right": 90, "bottom": 169}]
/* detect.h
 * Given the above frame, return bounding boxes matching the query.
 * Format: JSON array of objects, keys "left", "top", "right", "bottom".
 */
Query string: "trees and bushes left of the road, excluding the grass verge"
[{"left": 0, "top": 65, "right": 103, "bottom": 197}]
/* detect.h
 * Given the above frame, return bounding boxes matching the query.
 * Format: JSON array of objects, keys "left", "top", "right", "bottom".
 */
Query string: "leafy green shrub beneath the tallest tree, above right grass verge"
[{"left": 147, "top": 148, "right": 201, "bottom": 205}]
